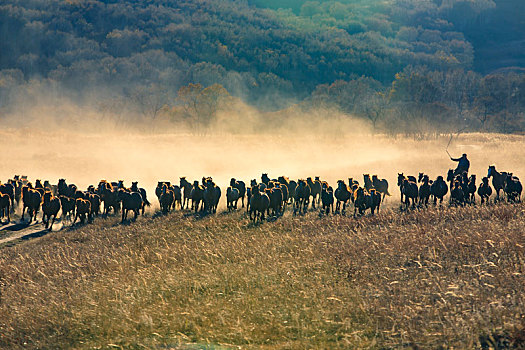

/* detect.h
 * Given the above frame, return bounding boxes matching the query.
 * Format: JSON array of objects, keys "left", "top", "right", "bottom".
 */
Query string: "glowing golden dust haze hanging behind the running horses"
[{"left": 0, "top": 104, "right": 525, "bottom": 209}]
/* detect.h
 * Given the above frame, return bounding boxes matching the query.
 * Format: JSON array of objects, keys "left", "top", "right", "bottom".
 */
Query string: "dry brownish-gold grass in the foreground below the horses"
[{"left": 0, "top": 205, "right": 525, "bottom": 349}]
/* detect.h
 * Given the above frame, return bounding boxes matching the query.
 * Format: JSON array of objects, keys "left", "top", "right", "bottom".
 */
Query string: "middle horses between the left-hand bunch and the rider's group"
[{"left": 155, "top": 174, "right": 382, "bottom": 222}]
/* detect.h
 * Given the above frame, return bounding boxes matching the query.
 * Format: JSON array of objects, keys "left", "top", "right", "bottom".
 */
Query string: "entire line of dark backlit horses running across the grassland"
[{"left": 0, "top": 165, "right": 523, "bottom": 230}]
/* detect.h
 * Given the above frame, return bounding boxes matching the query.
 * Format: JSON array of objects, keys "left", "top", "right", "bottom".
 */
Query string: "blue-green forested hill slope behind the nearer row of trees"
[{"left": 0, "top": 0, "right": 525, "bottom": 132}]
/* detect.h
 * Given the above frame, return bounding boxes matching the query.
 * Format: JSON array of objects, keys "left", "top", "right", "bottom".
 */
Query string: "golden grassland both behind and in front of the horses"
[{"left": 0, "top": 131, "right": 525, "bottom": 349}]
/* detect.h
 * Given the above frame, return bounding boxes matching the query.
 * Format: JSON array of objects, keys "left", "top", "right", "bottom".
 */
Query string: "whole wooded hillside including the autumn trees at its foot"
[{"left": 0, "top": 0, "right": 525, "bottom": 132}]
